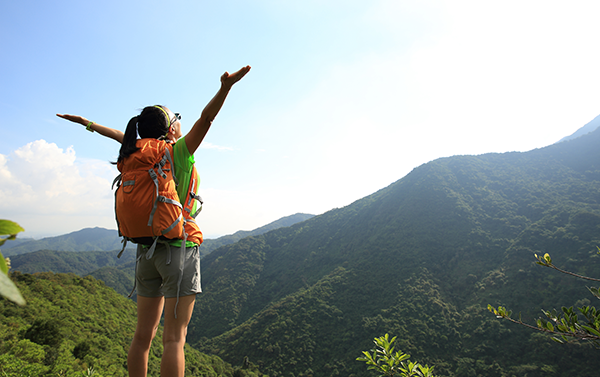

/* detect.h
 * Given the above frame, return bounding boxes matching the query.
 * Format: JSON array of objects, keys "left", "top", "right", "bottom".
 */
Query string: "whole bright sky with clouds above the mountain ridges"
[{"left": 0, "top": 0, "right": 600, "bottom": 238}]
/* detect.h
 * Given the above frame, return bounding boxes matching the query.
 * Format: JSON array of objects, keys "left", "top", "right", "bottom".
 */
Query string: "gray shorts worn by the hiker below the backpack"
[{"left": 135, "top": 243, "right": 202, "bottom": 298}]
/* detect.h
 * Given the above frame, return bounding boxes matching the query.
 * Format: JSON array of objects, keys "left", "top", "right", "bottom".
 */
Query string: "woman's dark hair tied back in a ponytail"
[{"left": 117, "top": 105, "right": 169, "bottom": 163}]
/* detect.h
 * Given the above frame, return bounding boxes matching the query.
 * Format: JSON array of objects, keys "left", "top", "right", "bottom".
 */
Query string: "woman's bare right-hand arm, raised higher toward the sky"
[{"left": 185, "top": 66, "right": 250, "bottom": 154}]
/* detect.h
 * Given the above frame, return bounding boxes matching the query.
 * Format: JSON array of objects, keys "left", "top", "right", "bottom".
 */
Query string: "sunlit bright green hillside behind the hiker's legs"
[{"left": 0, "top": 272, "right": 257, "bottom": 377}]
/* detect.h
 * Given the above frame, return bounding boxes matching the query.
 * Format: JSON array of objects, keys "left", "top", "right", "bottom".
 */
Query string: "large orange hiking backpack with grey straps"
[{"left": 113, "top": 139, "right": 202, "bottom": 256}]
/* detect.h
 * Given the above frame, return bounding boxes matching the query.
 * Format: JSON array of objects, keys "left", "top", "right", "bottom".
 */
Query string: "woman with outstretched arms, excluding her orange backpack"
[{"left": 56, "top": 66, "right": 250, "bottom": 377}]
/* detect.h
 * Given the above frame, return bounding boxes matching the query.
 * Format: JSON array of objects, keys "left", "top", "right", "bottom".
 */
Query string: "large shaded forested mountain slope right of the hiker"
[{"left": 188, "top": 129, "right": 600, "bottom": 376}]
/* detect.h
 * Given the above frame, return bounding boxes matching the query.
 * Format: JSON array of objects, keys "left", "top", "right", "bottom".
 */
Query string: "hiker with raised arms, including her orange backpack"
[{"left": 56, "top": 66, "right": 250, "bottom": 377}]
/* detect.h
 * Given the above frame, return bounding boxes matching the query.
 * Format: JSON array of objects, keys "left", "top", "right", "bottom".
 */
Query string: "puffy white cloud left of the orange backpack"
[{"left": 0, "top": 140, "right": 117, "bottom": 237}]
